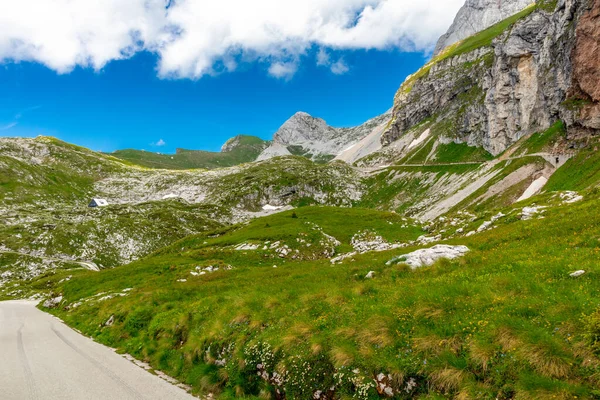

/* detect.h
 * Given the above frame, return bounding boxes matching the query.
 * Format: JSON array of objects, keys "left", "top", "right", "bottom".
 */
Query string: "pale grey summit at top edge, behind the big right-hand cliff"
[{"left": 434, "top": 0, "right": 534, "bottom": 55}]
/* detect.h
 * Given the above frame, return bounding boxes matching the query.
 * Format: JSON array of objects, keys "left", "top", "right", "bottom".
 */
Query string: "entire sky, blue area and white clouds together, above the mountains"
[{"left": 0, "top": 0, "right": 464, "bottom": 153}]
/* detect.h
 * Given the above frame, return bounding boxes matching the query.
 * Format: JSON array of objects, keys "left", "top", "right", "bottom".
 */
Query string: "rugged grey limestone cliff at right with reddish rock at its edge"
[{"left": 381, "top": 0, "right": 600, "bottom": 155}]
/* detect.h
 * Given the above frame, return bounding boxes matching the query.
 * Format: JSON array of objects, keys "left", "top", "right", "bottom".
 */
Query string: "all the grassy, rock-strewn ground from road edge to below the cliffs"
[{"left": 0, "top": 134, "right": 600, "bottom": 400}]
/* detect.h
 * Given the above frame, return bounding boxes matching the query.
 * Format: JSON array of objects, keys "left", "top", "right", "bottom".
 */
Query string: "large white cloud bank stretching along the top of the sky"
[{"left": 0, "top": 0, "right": 464, "bottom": 79}]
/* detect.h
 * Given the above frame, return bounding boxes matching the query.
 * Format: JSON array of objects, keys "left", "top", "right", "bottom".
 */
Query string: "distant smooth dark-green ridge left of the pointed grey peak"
[{"left": 111, "top": 135, "right": 269, "bottom": 169}]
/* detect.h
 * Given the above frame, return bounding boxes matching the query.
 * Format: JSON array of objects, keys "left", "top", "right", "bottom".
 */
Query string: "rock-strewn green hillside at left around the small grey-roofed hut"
[{"left": 0, "top": 137, "right": 361, "bottom": 292}]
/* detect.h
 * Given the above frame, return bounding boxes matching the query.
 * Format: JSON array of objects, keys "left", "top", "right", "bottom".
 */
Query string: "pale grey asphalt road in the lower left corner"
[{"left": 0, "top": 301, "right": 195, "bottom": 400}]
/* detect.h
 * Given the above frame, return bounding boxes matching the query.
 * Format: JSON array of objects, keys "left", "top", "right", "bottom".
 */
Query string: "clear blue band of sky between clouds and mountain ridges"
[{"left": 0, "top": 50, "right": 425, "bottom": 152}]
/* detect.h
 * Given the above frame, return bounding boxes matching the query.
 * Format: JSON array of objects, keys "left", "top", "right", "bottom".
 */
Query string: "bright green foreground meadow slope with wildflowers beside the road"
[{"left": 37, "top": 194, "right": 600, "bottom": 399}]
